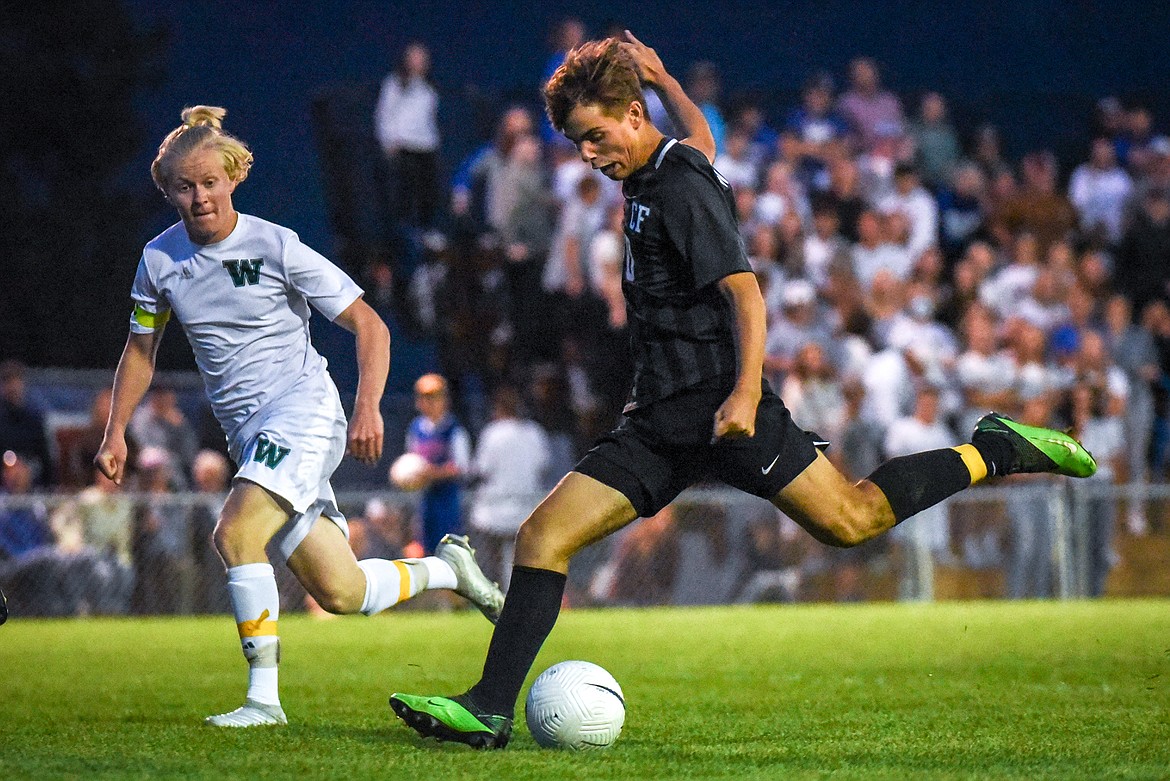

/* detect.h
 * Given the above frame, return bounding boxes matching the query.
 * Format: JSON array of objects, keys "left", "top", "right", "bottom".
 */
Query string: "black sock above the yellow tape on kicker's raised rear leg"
[{"left": 866, "top": 448, "right": 971, "bottom": 524}]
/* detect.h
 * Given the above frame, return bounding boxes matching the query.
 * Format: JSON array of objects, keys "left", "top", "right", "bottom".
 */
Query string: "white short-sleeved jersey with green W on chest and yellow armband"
[{"left": 130, "top": 214, "right": 362, "bottom": 441}]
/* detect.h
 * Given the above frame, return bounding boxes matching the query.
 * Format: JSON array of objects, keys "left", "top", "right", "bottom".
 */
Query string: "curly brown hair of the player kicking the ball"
[{"left": 544, "top": 37, "right": 646, "bottom": 131}]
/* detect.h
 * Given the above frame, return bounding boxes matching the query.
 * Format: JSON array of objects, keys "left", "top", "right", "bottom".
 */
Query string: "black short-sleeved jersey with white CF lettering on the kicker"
[{"left": 621, "top": 138, "right": 751, "bottom": 412}]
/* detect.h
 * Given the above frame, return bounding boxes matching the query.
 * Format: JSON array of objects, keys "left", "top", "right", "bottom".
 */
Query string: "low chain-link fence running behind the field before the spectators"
[{"left": 0, "top": 478, "right": 1170, "bottom": 616}]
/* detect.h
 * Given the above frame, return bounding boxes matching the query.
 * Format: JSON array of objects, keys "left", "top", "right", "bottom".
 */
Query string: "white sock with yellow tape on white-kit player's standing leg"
[{"left": 227, "top": 562, "right": 281, "bottom": 705}]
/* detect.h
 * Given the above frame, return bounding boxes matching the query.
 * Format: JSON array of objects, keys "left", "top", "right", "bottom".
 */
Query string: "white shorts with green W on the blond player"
[{"left": 228, "top": 382, "right": 350, "bottom": 560}]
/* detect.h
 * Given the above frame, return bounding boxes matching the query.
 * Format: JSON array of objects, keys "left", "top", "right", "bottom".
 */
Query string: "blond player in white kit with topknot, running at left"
[{"left": 95, "top": 106, "right": 503, "bottom": 727}]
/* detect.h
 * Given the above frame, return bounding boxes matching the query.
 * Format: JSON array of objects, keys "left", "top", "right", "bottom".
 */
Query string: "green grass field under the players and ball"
[{"left": 0, "top": 600, "right": 1170, "bottom": 781}]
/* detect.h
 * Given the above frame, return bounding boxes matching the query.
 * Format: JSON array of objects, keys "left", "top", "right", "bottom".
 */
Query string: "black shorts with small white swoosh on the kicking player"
[{"left": 573, "top": 386, "right": 817, "bottom": 518}]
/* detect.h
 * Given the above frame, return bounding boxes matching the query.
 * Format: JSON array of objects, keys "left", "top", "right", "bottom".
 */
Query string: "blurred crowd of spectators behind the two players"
[{"left": 0, "top": 20, "right": 1170, "bottom": 613}]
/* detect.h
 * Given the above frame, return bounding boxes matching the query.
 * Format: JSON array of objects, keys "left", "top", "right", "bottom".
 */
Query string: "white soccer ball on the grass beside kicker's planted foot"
[{"left": 524, "top": 662, "right": 626, "bottom": 751}]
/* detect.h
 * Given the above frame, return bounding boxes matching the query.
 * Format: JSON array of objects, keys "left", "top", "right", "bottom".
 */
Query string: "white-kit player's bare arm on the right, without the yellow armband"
[{"left": 336, "top": 298, "right": 390, "bottom": 464}]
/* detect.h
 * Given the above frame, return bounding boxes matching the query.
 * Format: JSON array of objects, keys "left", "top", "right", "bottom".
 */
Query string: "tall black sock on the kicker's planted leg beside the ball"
[{"left": 468, "top": 566, "right": 566, "bottom": 714}]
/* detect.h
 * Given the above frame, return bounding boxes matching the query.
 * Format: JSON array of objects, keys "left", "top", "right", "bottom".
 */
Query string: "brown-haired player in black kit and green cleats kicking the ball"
[{"left": 390, "top": 32, "right": 1096, "bottom": 748}]
